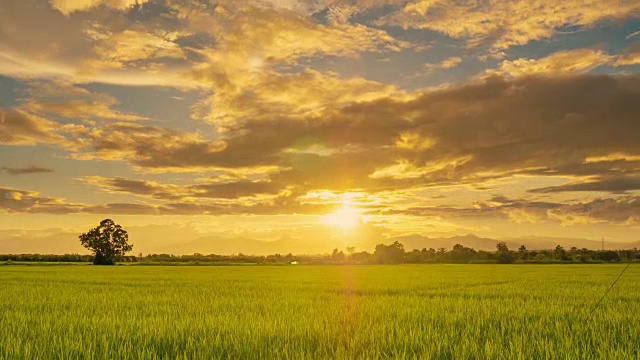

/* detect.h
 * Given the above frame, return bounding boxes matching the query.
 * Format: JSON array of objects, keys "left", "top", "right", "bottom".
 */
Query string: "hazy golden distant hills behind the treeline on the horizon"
[{"left": 0, "top": 225, "right": 640, "bottom": 255}]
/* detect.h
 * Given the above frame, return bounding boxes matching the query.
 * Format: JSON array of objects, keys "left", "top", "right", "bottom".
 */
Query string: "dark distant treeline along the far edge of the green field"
[{"left": 0, "top": 241, "right": 640, "bottom": 264}]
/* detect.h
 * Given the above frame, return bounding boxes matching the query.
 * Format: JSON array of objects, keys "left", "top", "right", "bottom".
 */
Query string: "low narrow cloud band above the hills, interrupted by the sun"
[{"left": 6, "top": 181, "right": 640, "bottom": 225}]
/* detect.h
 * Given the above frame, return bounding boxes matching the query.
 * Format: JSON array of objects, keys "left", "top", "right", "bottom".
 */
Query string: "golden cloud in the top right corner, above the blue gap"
[{"left": 379, "top": 0, "right": 640, "bottom": 50}]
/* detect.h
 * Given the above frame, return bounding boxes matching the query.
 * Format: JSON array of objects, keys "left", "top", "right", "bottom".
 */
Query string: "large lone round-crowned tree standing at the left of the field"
[{"left": 79, "top": 219, "right": 133, "bottom": 265}]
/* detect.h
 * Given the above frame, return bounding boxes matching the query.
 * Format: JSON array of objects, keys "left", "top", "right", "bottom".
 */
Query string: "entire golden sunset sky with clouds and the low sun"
[{"left": 0, "top": 0, "right": 640, "bottom": 252}]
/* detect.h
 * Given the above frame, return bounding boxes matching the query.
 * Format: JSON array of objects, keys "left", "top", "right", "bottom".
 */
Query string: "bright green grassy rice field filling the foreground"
[{"left": 0, "top": 264, "right": 640, "bottom": 359}]
